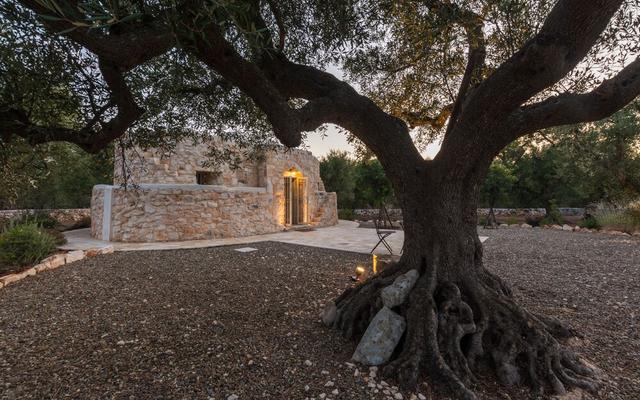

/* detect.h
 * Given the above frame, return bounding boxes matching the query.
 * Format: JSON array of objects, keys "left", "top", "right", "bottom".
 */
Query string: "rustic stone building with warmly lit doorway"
[{"left": 91, "top": 142, "right": 338, "bottom": 242}]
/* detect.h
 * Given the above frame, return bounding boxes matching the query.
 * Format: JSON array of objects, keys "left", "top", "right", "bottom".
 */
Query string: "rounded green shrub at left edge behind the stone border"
[{"left": 0, "top": 223, "right": 56, "bottom": 272}]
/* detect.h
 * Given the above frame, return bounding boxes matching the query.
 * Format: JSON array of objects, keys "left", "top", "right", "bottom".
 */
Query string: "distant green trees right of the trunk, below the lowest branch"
[{"left": 481, "top": 102, "right": 640, "bottom": 210}]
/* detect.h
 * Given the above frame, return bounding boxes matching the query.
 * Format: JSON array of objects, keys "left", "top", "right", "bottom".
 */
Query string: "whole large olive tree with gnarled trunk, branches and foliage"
[{"left": 0, "top": 0, "right": 640, "bottom": 399}]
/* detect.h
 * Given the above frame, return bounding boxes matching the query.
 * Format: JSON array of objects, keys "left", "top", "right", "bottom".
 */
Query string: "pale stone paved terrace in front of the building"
[{"left": 61, "top": 220, "right": 487, "bottom": 254}]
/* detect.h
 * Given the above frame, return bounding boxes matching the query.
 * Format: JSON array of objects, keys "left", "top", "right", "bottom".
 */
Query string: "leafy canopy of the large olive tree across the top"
[{"left": 0, "top": 0, "right": 640, "bottom": 159}]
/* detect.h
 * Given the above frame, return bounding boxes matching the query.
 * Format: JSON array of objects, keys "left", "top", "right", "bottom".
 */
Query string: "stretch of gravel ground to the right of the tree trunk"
[{"left": 480, "top": 228, "right": 640, "bottom": 400}]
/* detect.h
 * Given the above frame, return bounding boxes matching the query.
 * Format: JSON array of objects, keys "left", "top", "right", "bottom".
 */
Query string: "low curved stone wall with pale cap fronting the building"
[{"left": 92, "top": 185, "right": 281, "bottom": 242}]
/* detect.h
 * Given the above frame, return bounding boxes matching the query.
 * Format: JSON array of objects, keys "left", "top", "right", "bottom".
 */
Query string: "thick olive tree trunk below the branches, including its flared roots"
[{"left": 333, "top": 177, "right": 596, "bottom": 399}]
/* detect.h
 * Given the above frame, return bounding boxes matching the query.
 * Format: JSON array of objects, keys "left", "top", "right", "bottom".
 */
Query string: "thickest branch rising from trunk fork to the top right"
[{"left": 435, "top": 0, "right": 623, "bottom": 173}]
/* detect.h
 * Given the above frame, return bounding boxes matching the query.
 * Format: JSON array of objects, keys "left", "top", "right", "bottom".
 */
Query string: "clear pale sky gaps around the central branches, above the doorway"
[{"left": 306, "top": 65, "right": 440, "bottom": 158}]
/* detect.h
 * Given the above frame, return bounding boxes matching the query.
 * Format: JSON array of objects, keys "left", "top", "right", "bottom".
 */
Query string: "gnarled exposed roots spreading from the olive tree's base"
[{"left": 334, "top": 264, "right": 598, "bottom": 399}]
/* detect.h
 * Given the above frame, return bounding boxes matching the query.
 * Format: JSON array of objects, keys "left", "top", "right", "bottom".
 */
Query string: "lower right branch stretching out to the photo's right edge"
[{"left": 505, "top": 57, "right": 640, "bottom": 141}]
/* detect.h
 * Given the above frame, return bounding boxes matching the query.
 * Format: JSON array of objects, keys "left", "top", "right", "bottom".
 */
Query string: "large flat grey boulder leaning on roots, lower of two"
[{"left": 351, "top": 307, "right": 406, "bottom": 365}]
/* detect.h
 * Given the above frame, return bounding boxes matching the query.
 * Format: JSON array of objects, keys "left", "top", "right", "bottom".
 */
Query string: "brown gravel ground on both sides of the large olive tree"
[{"left": 0, "top": 229, "right": 640, "bottom": 399}]
